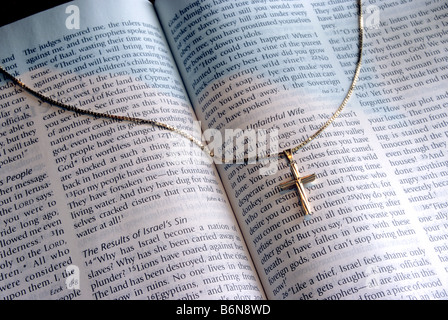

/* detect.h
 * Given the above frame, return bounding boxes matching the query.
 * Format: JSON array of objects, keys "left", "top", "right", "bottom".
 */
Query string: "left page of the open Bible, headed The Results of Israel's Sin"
[{"left": 0, "top": 0, "right": 264, "bottom": 299}]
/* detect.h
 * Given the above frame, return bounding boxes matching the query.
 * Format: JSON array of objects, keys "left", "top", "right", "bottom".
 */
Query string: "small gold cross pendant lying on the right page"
[{"left": 280, "top": 150, "right": 316, "bottom": 220}]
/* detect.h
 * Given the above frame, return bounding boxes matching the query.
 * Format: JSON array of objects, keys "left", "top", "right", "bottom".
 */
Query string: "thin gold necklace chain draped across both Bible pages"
[{"left": 0, "top": 0, "right": 364, "bottom": 163}]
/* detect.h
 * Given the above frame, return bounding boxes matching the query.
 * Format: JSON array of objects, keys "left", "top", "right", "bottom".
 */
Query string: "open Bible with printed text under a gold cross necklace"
[{"left": 0, "top": 0, "right": 448, "bottom": 300}]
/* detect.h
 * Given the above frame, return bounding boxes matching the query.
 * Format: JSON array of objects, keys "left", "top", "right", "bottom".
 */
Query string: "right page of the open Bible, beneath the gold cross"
[{"left": 156, "top": 0, "right": 448, "bottom": 300}]
